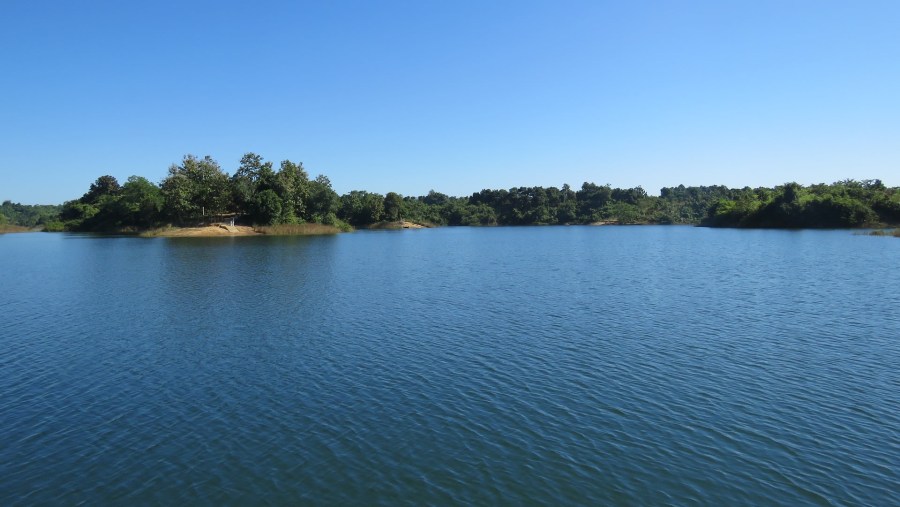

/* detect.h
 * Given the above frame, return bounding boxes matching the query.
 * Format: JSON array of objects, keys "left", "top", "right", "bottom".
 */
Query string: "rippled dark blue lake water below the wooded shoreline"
[{"left": 0, "top": 226, "right": 900, "bottom": 506}]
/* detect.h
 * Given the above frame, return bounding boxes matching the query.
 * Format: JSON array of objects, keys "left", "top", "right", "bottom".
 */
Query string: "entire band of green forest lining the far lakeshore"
[{"left": 0, "top": 153, "right": 900, "bottom": 232}]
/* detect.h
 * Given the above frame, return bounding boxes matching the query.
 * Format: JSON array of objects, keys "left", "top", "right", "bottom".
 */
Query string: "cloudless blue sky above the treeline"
[{"left": 0, "top": 0, "right": 900, "bottom": 204}]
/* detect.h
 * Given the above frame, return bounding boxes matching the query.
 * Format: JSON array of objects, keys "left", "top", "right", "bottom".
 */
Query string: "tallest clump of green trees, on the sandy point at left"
[{"left": 60, "top": 153, "right": 349, "bottom": 234}]
